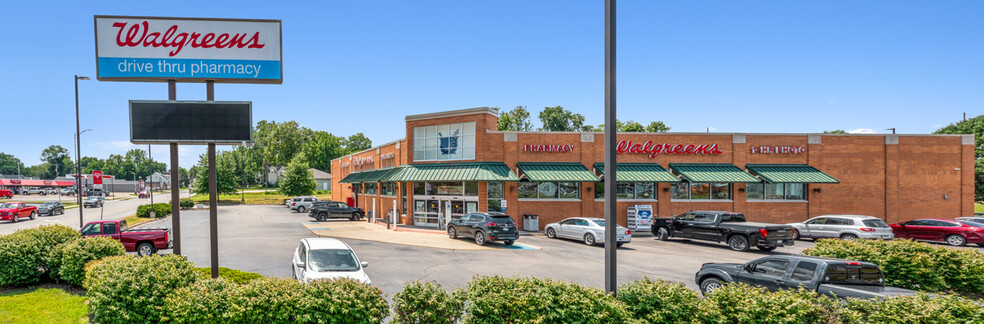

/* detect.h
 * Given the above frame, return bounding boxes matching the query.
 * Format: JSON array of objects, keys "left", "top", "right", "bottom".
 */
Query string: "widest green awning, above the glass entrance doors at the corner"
[{"left": 380, "top": 162, "right": 519, "bottom": 182}]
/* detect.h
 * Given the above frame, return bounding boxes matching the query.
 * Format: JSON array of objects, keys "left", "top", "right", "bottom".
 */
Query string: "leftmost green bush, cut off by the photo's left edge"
[{"left": 0, "top": 225, "right": 80, "bottom": 286}]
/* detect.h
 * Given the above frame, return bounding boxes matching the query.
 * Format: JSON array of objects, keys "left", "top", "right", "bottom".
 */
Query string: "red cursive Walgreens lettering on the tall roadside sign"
[{"left": 113, "top": 20, "right": 266, "bottom": 56}]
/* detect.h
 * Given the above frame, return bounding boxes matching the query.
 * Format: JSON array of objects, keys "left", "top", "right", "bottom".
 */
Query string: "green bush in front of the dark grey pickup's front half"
[{"left": 700, "top": 283, "right": 836, "bottom": 324}]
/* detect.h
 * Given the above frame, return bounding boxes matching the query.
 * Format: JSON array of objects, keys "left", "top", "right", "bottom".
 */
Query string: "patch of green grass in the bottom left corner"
[{"left": 0, "top": 288, "right": 88, "bottom": 323}]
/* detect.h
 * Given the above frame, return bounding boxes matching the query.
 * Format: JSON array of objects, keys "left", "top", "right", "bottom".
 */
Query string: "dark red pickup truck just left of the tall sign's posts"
[{"left": 79, "top": 220, "right": 172, "bottom": 256}]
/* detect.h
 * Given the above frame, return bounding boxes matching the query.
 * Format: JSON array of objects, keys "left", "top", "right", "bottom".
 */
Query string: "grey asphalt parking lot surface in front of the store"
[{"left": 145, "top": 206, "right": 813, "bottom": 295}]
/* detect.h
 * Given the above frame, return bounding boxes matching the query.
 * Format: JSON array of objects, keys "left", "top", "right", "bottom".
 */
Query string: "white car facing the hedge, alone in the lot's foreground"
[{"left": 291, "top": 237, "right": 372, "bottom": 285}]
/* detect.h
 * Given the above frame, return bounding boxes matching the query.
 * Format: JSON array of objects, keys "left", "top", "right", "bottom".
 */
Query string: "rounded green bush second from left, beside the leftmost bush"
[{"left": 53, "top": 236, "right": 126, "bottom": 286}]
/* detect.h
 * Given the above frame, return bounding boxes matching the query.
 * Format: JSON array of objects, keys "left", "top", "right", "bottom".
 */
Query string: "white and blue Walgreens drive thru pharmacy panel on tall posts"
[{"left": 94, "top": 16, "right": 283, "bottom": 84}]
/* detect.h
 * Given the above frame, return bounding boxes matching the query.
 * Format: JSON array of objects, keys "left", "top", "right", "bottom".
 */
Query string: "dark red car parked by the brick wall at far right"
[{"left": 891, "top": 219, "right": 984, "bottom": 246}]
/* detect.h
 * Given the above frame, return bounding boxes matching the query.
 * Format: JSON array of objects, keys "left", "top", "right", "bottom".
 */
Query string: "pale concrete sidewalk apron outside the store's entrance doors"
[{"left": 302, "top": 220, "right": 540, "bottom": 250}]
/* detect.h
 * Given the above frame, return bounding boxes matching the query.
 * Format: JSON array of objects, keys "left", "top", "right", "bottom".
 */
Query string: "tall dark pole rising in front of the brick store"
[{"left": 605, "top": 0, "right": 618, "bottom": 296}]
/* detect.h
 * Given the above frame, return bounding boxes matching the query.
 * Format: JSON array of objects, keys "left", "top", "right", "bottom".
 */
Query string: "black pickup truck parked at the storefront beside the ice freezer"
[{"left": 652, "top": 211, "right": 795, "bottom": 252}]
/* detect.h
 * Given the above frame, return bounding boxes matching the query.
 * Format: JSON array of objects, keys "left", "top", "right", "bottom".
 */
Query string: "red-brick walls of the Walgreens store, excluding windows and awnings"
[{"left": 331, "top": 109, "right": 974, "bottom": 229}]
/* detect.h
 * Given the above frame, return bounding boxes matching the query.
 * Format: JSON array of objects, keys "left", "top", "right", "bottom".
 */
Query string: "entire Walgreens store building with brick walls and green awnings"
[{"left": 331, "top": 108, "right": 974, "bottom": 230}]
